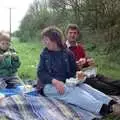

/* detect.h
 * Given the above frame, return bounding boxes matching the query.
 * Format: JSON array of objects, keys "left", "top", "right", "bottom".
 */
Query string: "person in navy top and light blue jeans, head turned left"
[{"left": 37, "top": 27, "right": 116, "bottom": 115}]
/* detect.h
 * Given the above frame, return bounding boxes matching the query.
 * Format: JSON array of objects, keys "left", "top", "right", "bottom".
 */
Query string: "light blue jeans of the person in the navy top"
[{"left": 44, "top": 83, "right": 112, "bottom": 114}]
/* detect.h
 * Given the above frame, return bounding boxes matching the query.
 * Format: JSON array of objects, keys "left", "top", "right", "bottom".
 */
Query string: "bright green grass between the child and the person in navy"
[{"left": 12, "top": 40, "right": 42, "bottom": 79}]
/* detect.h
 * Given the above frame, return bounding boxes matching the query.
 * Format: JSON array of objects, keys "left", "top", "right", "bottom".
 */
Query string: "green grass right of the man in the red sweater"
[{"left": 88, "top": 51, "right": 120, "bottom": 80}]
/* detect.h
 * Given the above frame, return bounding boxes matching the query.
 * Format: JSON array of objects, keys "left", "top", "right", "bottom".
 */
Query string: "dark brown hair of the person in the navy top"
[{"left": 41, "top": 26, "right": 64, "bottom": 48}]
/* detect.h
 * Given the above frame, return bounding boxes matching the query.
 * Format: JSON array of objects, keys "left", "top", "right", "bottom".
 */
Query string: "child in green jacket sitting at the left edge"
[{"left": 0, "top": 32, "right": 20, "bottom": 88}]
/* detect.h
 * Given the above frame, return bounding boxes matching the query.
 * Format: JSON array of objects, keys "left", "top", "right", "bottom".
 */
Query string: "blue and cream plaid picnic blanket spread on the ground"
[{"left": 0, "top": 86, "right": 100, "bottom": 120}]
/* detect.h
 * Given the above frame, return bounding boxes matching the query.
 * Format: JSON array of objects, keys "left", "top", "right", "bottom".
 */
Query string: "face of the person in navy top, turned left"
[{"left": 43, "top": 36, "right": 57, "bottom": 50}]
